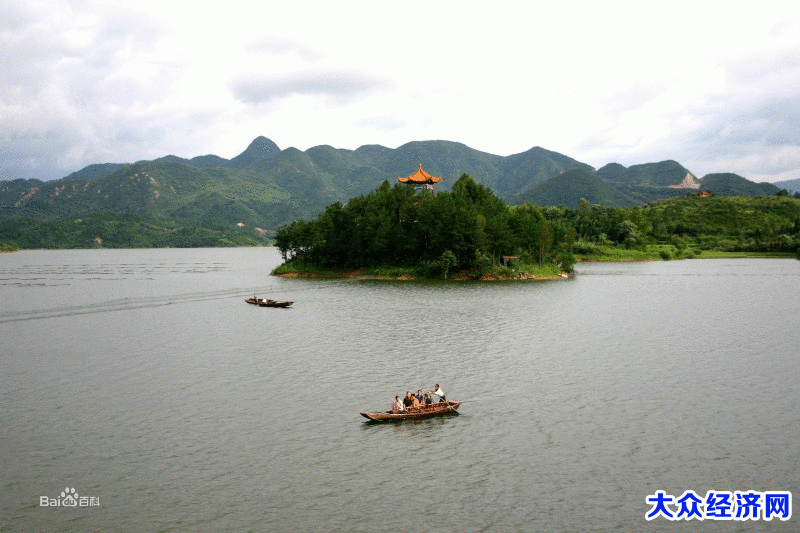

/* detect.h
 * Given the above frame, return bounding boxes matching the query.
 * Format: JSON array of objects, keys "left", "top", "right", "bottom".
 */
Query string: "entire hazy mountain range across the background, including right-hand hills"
[{"left": 0, "top": 137, "right": 779, "bottom": 237}]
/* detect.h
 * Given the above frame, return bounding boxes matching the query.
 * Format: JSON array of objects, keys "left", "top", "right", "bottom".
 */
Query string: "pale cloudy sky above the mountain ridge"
[{"left": 0, "top": 0, "right": 800, "bottom": 181}]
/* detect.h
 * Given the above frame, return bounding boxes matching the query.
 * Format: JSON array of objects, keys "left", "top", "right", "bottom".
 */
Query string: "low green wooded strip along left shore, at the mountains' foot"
[{"left": 0, "top": 213, "right": 267, "bottom": 248}]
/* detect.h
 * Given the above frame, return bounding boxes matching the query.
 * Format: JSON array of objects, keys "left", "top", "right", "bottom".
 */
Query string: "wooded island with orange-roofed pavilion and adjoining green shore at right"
[{"left": 272, "top": 170, "right": 800, "bottom": 280}]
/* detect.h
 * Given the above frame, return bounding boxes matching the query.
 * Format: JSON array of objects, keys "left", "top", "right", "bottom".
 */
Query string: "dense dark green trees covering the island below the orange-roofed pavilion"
[{"left": 275, "top": 174, "right": 575, "bottom": 278}]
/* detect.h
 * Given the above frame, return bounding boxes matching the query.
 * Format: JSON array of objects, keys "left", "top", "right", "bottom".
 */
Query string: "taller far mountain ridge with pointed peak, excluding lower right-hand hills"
[{"left": 0, "top": 137, "right": 591, "bottom": 233}]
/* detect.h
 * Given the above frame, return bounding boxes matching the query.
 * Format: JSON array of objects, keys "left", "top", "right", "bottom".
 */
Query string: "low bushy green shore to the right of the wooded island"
[{"left": 560, "top": 195, "right": 800, "bottom": 261}]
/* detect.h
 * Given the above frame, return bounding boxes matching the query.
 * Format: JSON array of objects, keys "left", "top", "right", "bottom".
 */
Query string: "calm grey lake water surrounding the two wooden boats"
[{"left": 0, "top": 248, "right": 800, "bottom": 532}]
